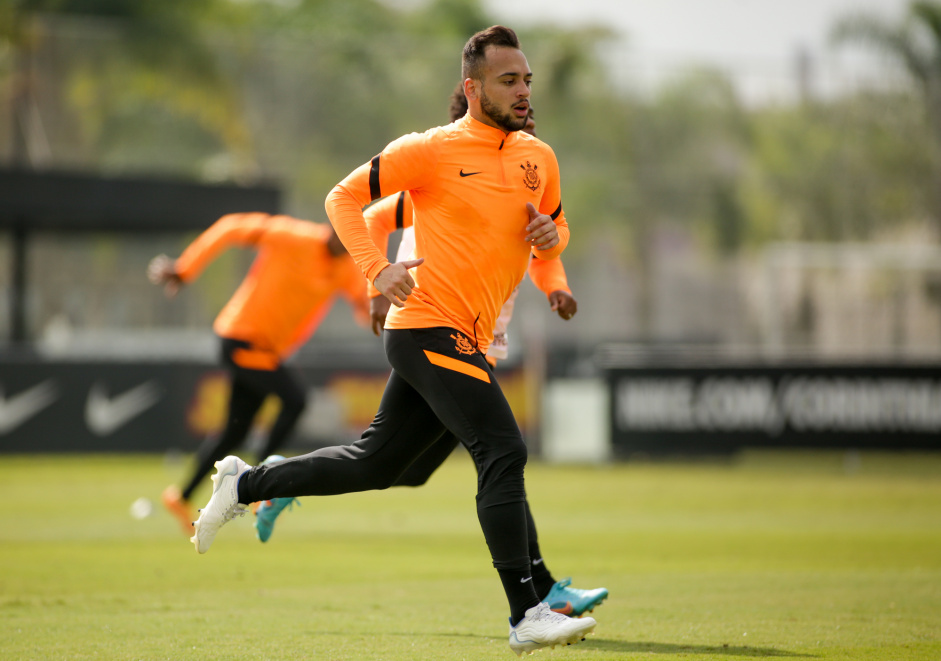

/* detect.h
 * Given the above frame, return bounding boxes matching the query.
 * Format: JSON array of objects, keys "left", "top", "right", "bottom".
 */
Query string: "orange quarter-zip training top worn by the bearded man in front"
[{"left": 326, "top": 114, "right": 569, "bottom": 353}]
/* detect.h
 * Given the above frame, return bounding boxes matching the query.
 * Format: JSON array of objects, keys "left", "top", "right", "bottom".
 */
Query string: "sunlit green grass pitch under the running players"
[{"left": 0, "top": 453, "right": 941, "bottom": 661}]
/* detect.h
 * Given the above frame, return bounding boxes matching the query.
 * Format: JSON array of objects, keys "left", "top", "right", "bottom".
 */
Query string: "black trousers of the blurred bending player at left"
[{"left": 181, "top": 338, "right": 306, "bottom": 500}]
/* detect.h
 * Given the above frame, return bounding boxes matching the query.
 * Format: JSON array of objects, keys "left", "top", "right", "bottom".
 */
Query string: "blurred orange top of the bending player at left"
[{"left": 176, "top": 213, "right": 369, "bottom": 370}]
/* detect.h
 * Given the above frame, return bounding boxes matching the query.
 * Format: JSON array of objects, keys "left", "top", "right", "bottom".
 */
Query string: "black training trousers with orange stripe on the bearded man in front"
[{"left": 239, "top": 328, "right": 538, "bottom": 576}]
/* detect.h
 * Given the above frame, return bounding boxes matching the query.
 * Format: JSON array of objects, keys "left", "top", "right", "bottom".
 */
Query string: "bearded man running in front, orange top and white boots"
[{"left": 192, "top": 26, "right": 596, "bottom": 654}]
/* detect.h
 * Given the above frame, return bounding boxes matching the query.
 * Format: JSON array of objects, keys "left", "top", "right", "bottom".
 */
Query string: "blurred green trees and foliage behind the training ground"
[{"left": 0, "top": 0, "right": 941, "bottom": 356}]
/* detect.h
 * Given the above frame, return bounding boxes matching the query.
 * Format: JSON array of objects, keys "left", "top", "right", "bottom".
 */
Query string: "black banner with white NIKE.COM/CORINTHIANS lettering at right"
[{"left": 607, "top": 365, "right": 941, "bottom": 457}]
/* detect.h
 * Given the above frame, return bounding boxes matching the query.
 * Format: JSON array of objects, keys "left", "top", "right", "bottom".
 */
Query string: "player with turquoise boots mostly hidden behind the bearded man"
[{"left": 256, "top": 85, "right": 608, "bottom": 616}]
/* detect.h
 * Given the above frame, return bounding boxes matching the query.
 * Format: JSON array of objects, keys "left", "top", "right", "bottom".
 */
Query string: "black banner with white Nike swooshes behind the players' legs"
[{"left": 0, "top": 360, "right": 532, "bottom": 454}]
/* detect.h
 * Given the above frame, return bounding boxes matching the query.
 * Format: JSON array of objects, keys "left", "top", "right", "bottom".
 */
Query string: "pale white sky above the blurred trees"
[{"left": 484, "top": 0, "right": 909, "bottom": 100}]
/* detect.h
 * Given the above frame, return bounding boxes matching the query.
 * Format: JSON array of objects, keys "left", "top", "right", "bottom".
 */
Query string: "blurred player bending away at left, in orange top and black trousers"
[{"left": 147, "top": 213, "right": 369, "bottom": 535}]
